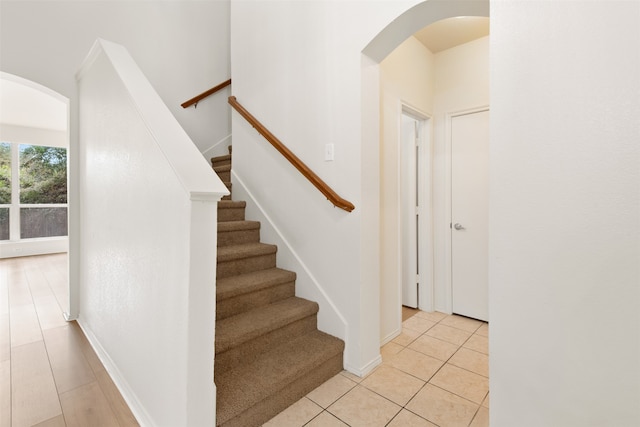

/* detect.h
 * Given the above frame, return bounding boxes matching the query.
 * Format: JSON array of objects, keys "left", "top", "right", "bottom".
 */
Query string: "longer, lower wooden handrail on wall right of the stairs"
[{"left": 229, "top": 96, "right": 355, "bottom": 212}]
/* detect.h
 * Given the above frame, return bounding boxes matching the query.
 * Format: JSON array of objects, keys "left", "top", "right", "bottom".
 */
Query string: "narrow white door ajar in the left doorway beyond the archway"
[{"left": 400, "top": 114, "right": 420, "bottom": 308}]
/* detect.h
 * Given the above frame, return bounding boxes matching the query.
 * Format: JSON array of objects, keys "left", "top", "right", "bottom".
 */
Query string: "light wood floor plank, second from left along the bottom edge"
[{"left": 11, "top": 341, "right": 62, "bottom": 426}]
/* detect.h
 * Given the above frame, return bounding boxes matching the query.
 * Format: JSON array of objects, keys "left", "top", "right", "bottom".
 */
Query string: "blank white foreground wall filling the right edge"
[{"left": 489, "top": 1, "right": 640, "bottom": 427}]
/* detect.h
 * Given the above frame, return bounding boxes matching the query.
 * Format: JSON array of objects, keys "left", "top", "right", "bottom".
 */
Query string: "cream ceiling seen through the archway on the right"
[{"left": 414, "top": 16, "right": 489, "bottom": 53}]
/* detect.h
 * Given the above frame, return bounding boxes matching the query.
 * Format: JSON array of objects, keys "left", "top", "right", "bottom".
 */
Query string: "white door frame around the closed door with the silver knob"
[{"left": 444, "top": 104, "right": 491, "bottom": 314}]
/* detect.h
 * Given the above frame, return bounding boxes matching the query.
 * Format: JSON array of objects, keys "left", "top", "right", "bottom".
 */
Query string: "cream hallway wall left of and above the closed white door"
[{"left": 433, "top": 37, "right": 490, "bottom": 313}]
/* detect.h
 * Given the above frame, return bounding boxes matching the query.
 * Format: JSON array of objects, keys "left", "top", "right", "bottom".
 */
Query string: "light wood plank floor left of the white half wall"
[{"left": 0, "top": 254, "right": 138, "bottom": 427}]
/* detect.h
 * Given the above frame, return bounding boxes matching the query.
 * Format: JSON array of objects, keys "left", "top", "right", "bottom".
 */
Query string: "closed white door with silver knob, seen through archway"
[{"left": 451, "top": 110, "right": 489, "bottom": 321}]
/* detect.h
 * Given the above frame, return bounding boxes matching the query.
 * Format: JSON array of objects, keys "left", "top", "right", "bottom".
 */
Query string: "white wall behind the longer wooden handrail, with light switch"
[{"left": 231, "top": 1, "right": 415, "bottom": 373}]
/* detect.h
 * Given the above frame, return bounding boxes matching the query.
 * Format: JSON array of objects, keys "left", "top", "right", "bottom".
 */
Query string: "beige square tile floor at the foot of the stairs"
[{"left": 265, "top": 311, "right": 489, "bottom": 427}]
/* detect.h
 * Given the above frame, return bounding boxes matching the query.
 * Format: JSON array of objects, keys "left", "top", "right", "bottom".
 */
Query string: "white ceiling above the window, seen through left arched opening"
[{"left": 0, "top": 76, "right": 67, "bottom": 131}]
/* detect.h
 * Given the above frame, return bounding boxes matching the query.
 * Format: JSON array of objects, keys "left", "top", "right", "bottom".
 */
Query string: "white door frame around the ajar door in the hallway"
[{"left": 396, "top": 100, "right": 434, "bottom": 314}]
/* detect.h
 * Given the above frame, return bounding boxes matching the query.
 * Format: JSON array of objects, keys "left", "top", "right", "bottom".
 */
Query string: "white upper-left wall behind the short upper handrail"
[{"left": 0, "top": 0, "right": 230, "bottom": 155}]
